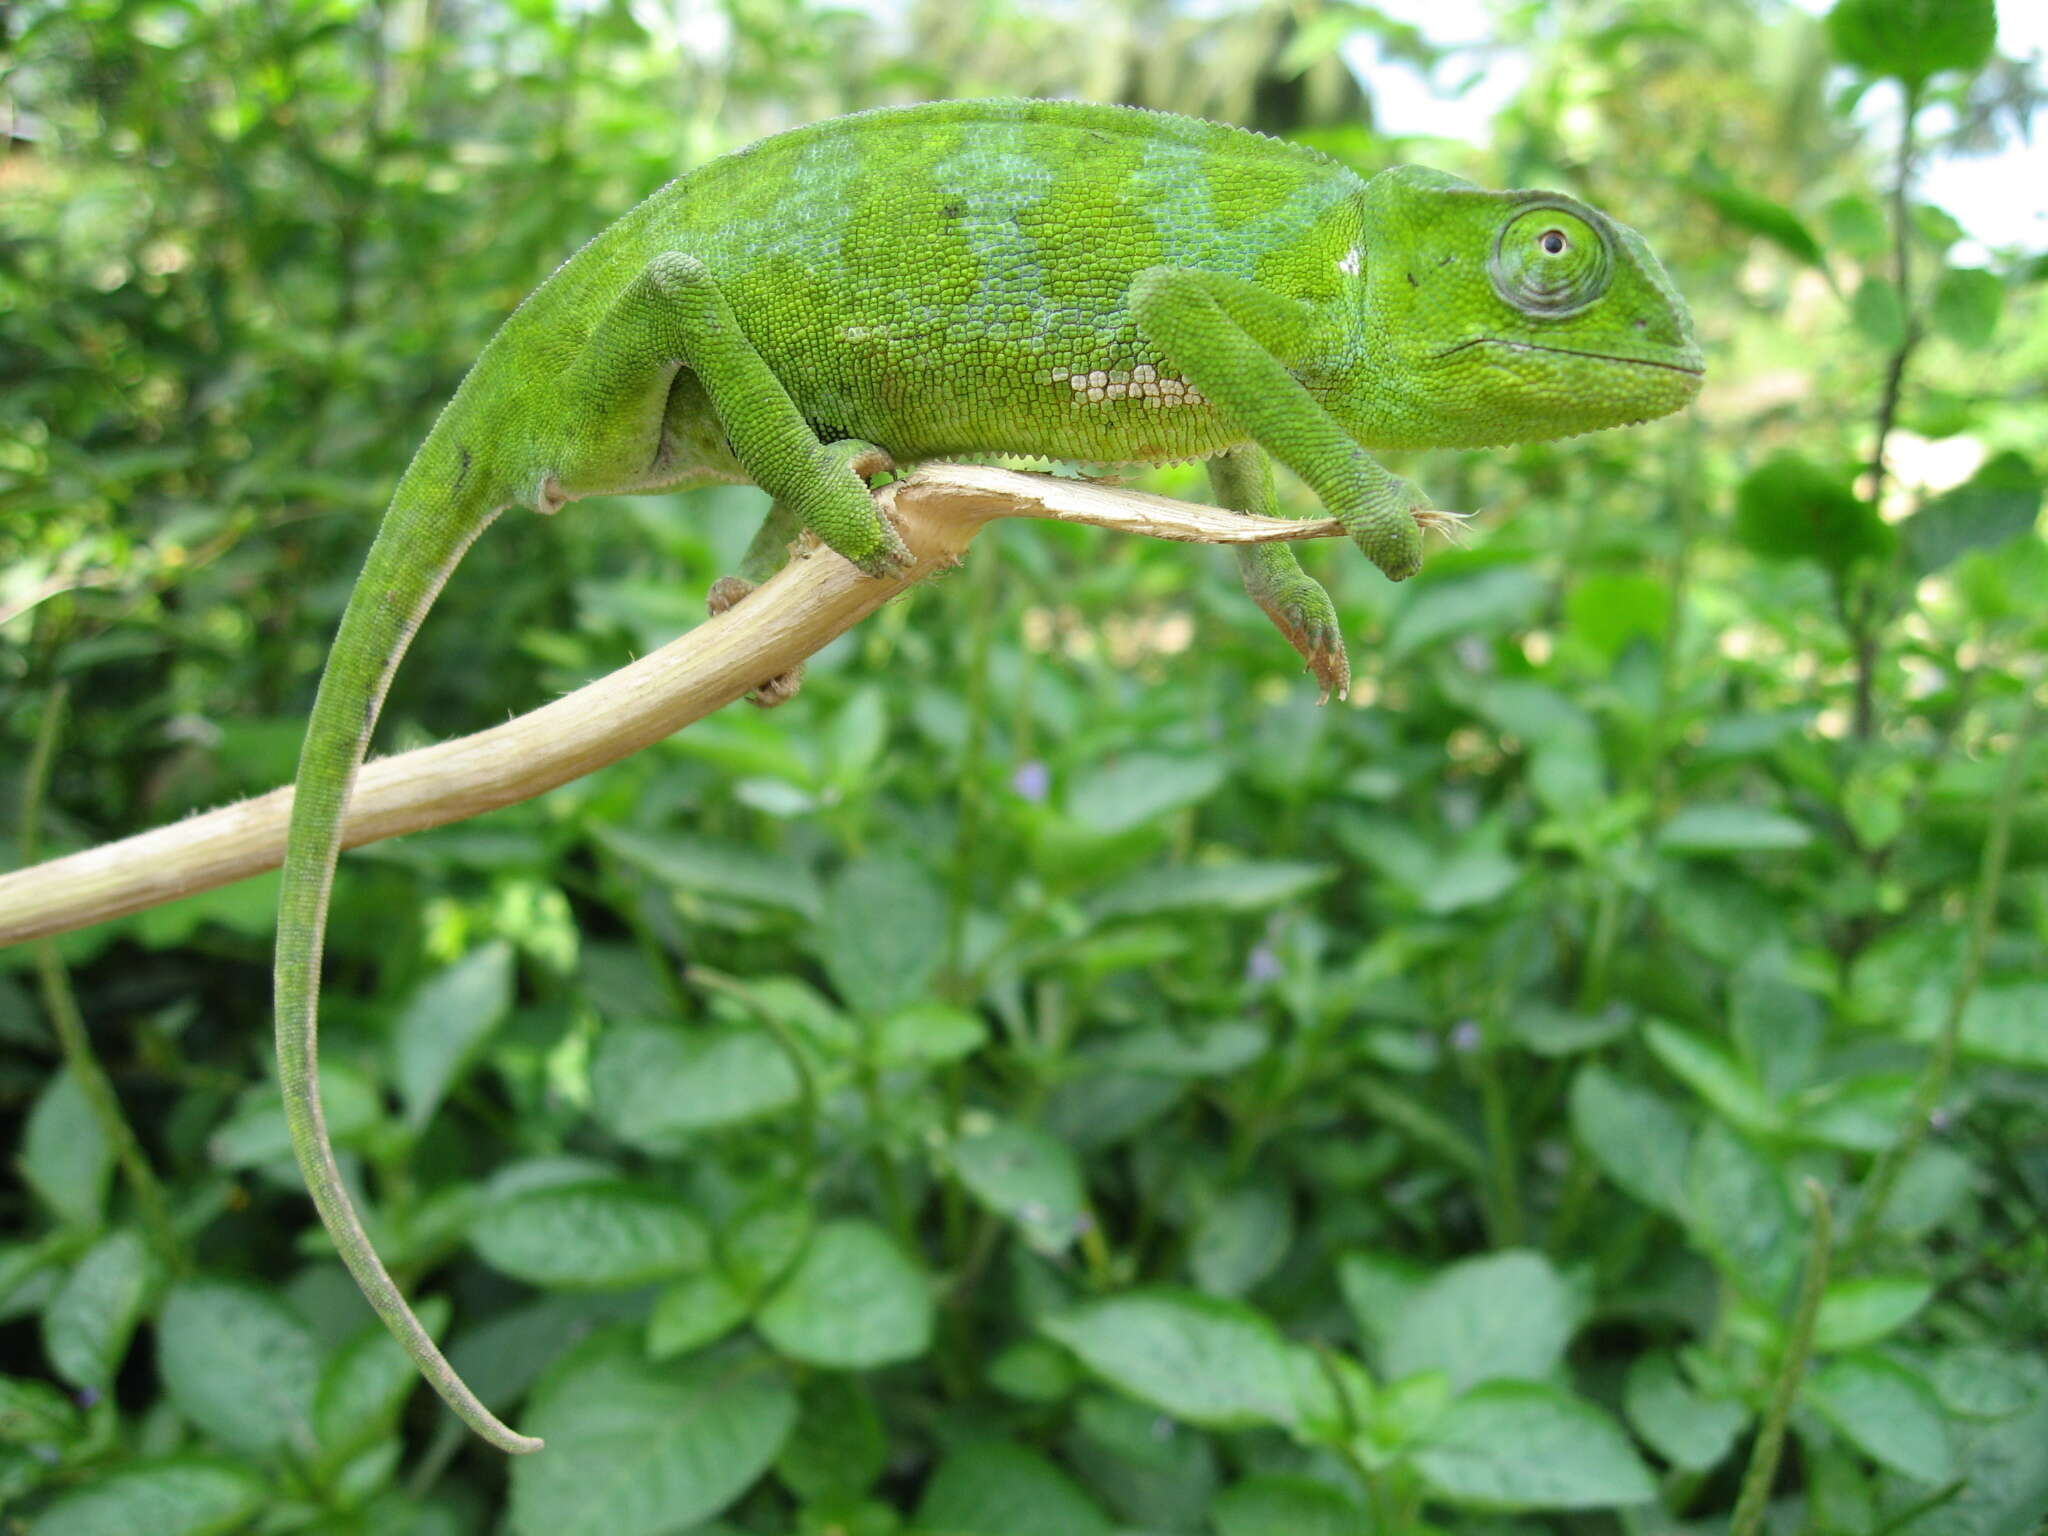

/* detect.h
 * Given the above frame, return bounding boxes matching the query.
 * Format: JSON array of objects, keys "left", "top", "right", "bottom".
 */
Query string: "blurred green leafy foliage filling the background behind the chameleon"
[{"left": 0, "top": 0, "right": 2048, "bottom": 1536}]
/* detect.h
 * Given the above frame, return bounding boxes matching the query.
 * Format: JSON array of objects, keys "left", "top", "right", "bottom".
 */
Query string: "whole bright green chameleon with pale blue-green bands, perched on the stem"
[{"left": 276, "top": 100, "right": 1702, "bottom": 1452}]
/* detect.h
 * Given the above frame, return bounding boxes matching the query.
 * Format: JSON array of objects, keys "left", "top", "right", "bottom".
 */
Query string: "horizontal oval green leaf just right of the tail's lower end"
[{"left": 469, "top": 1180, "right": 711, "bottom": 1290}]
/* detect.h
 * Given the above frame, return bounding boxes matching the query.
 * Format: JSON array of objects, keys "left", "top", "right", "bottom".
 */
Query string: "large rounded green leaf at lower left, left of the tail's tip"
[{"left": 156, "top": 1280, "right": 319, "bottom": 1454}]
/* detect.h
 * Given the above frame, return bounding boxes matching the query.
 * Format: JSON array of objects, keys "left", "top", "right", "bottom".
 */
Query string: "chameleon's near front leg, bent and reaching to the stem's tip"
[{"left": 1130, "top": 266, "right": 1430, "bottom": 582}]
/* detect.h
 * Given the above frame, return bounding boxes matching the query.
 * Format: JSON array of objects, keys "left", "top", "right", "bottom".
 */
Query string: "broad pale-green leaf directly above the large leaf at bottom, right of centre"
[{"left": 1380, "top": 1249, "right": 1579, "bottom": 1391}]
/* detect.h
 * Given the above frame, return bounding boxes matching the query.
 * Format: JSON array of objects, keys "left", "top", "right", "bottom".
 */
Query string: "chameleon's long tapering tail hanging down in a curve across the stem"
[{"left": 276, "top": 475, "right": 541, "bottom": 1452}]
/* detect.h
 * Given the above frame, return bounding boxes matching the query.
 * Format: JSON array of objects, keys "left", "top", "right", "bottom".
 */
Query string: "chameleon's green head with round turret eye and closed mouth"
[{"left": 1362, "top": 166, "right": 1706, "bottom": 449}]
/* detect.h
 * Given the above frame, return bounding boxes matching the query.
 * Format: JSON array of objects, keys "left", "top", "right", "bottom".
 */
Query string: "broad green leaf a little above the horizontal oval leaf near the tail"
[{"left": 590, "top": 1024, "right": 803, "bottom": 1153}]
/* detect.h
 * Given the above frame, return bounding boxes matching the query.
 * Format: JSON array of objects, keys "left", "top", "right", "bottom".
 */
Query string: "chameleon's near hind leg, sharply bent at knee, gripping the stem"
[{"left": 555, "top": 252, "right": 909, "bottom": 575}]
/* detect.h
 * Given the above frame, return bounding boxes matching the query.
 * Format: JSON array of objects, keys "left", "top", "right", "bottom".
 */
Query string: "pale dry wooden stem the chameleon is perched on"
[{"left": 0, "top": 465, "right": 1343, "bottom": 946}]
